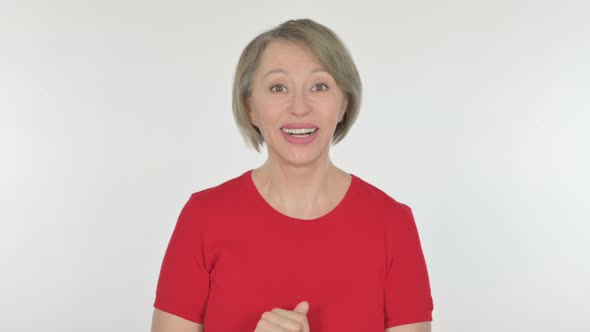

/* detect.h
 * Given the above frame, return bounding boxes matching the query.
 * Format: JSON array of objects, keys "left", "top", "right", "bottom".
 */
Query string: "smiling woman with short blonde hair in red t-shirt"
[{"left": 152, "top": 19, "right": 433, "bottom": 332}]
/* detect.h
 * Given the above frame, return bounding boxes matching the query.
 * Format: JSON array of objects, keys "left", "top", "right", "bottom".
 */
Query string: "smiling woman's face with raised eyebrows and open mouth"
[{"left": 248, "top": 41, "right": 347, "bottom": 166}]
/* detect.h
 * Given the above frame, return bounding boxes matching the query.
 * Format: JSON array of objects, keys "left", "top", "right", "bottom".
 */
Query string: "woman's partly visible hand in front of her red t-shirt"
[{"left": 254, "top": 301, "right": 310, "bottom": 332}]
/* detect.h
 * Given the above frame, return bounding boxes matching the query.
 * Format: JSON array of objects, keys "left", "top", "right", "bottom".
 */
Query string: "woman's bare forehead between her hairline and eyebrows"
[{"left": 260, "top": 40, "right": 324, "bottom": 69}]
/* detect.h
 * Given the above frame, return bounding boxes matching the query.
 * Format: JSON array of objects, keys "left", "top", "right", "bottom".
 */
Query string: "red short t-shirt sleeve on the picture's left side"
[{"left": 154, "top": 194, "right": 210, "bottom": 324}]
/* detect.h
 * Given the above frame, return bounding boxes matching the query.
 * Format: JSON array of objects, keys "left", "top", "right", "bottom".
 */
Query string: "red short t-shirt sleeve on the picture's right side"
[{"left": 384, "top": 203, "right": 433, "bottom": 328}]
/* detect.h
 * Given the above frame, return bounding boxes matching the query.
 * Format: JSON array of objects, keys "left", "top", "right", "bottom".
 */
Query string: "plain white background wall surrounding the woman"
[{"left": 0, "top": 0, "right": 590, "bottom": 332}]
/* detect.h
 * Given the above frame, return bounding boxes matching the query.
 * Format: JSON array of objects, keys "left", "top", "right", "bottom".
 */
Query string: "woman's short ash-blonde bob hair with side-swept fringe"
[{"left": 232, "top": 19, "right": 362, "bottom": 152}]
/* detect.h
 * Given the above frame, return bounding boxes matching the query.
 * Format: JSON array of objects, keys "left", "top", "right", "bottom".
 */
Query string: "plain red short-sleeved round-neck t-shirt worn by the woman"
[{"left": 154, "top": 170, "right": 433, "bottom": 332}]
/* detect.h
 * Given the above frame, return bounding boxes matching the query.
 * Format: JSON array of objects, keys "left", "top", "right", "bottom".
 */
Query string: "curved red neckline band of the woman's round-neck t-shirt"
[{"left": 242, "top": 169, "right": 358, "bottom": 227}]
